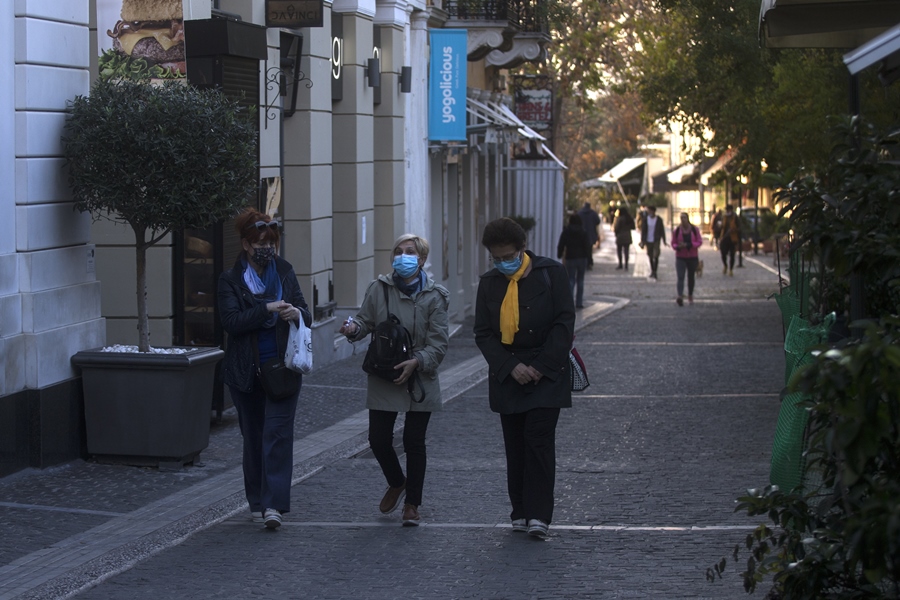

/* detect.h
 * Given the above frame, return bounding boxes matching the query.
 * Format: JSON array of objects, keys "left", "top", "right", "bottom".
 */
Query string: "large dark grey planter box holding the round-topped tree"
[{"left": 72, "top": 348, "right": 225, "bottom": 466}]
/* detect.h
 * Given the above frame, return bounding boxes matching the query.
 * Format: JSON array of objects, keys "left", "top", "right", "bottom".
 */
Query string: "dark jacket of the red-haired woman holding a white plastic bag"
[{"left": 218, "top": 255, "right": 312, "bottom": 393}]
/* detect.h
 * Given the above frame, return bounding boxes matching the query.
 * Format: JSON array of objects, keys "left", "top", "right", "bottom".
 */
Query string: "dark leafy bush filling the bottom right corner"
[{"left": 707, "top": 316, "right": 900, "bottom": 600}]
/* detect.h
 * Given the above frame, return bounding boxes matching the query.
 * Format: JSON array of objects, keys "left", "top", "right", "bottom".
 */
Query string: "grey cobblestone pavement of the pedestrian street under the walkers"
[{"left": 0, "top": 227, "right": 784, "bottom": 599}]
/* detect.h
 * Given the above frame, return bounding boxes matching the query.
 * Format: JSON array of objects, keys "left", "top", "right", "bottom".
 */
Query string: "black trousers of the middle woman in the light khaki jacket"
[{"left": 369, "top": 410, "right": 431, "bottom": 506}]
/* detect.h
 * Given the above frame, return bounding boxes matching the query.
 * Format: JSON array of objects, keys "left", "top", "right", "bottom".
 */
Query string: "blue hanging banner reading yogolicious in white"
[{"left": 428, "top": 29, "right": 467, "bottom": 142}]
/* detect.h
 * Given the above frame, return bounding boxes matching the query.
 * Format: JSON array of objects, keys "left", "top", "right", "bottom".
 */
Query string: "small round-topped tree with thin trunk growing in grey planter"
[{"left": 63, "top": 80, "right": 257, "bottom": 352}]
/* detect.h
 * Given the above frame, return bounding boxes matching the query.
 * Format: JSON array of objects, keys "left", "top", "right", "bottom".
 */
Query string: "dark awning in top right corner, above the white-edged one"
[{"left": 759, "top": 0, "right": 900, "bottom": 48}]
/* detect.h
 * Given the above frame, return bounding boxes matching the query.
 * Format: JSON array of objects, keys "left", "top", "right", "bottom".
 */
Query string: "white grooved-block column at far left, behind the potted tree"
[{"left": 11, "top": 0, "right": 105, "bottom": 389}]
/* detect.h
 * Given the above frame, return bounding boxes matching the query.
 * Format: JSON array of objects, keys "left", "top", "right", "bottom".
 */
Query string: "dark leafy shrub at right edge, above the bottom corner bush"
[{"left": 775, "top": 117, "right": 900, "bottom": 316}]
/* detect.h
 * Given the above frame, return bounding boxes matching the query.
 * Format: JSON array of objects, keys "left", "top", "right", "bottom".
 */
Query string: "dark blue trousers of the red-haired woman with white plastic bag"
[{"left": 229, "top": 380, "right": 300, "bottom": 513}]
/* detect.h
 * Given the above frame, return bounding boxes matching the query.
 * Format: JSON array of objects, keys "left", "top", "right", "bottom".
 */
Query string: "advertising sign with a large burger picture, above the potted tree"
[{"left": 97, "top": 0, "right": 187, "bottom": 79}]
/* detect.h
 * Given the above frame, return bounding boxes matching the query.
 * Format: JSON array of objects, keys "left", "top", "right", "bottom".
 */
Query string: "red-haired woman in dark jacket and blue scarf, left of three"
[{"left": 218, "top": 209, "right": 312, "bottom": 529}]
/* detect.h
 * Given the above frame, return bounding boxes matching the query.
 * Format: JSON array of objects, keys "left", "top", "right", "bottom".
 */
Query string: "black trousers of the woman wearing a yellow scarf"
[{"left": 500, "top": 408, "right": 559, "bottom": 523}]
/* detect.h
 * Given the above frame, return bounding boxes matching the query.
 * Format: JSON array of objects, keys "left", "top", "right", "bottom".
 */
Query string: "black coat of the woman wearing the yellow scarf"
[{"left": 474, "top": 252, "right": 575, "bottom": 414}]
